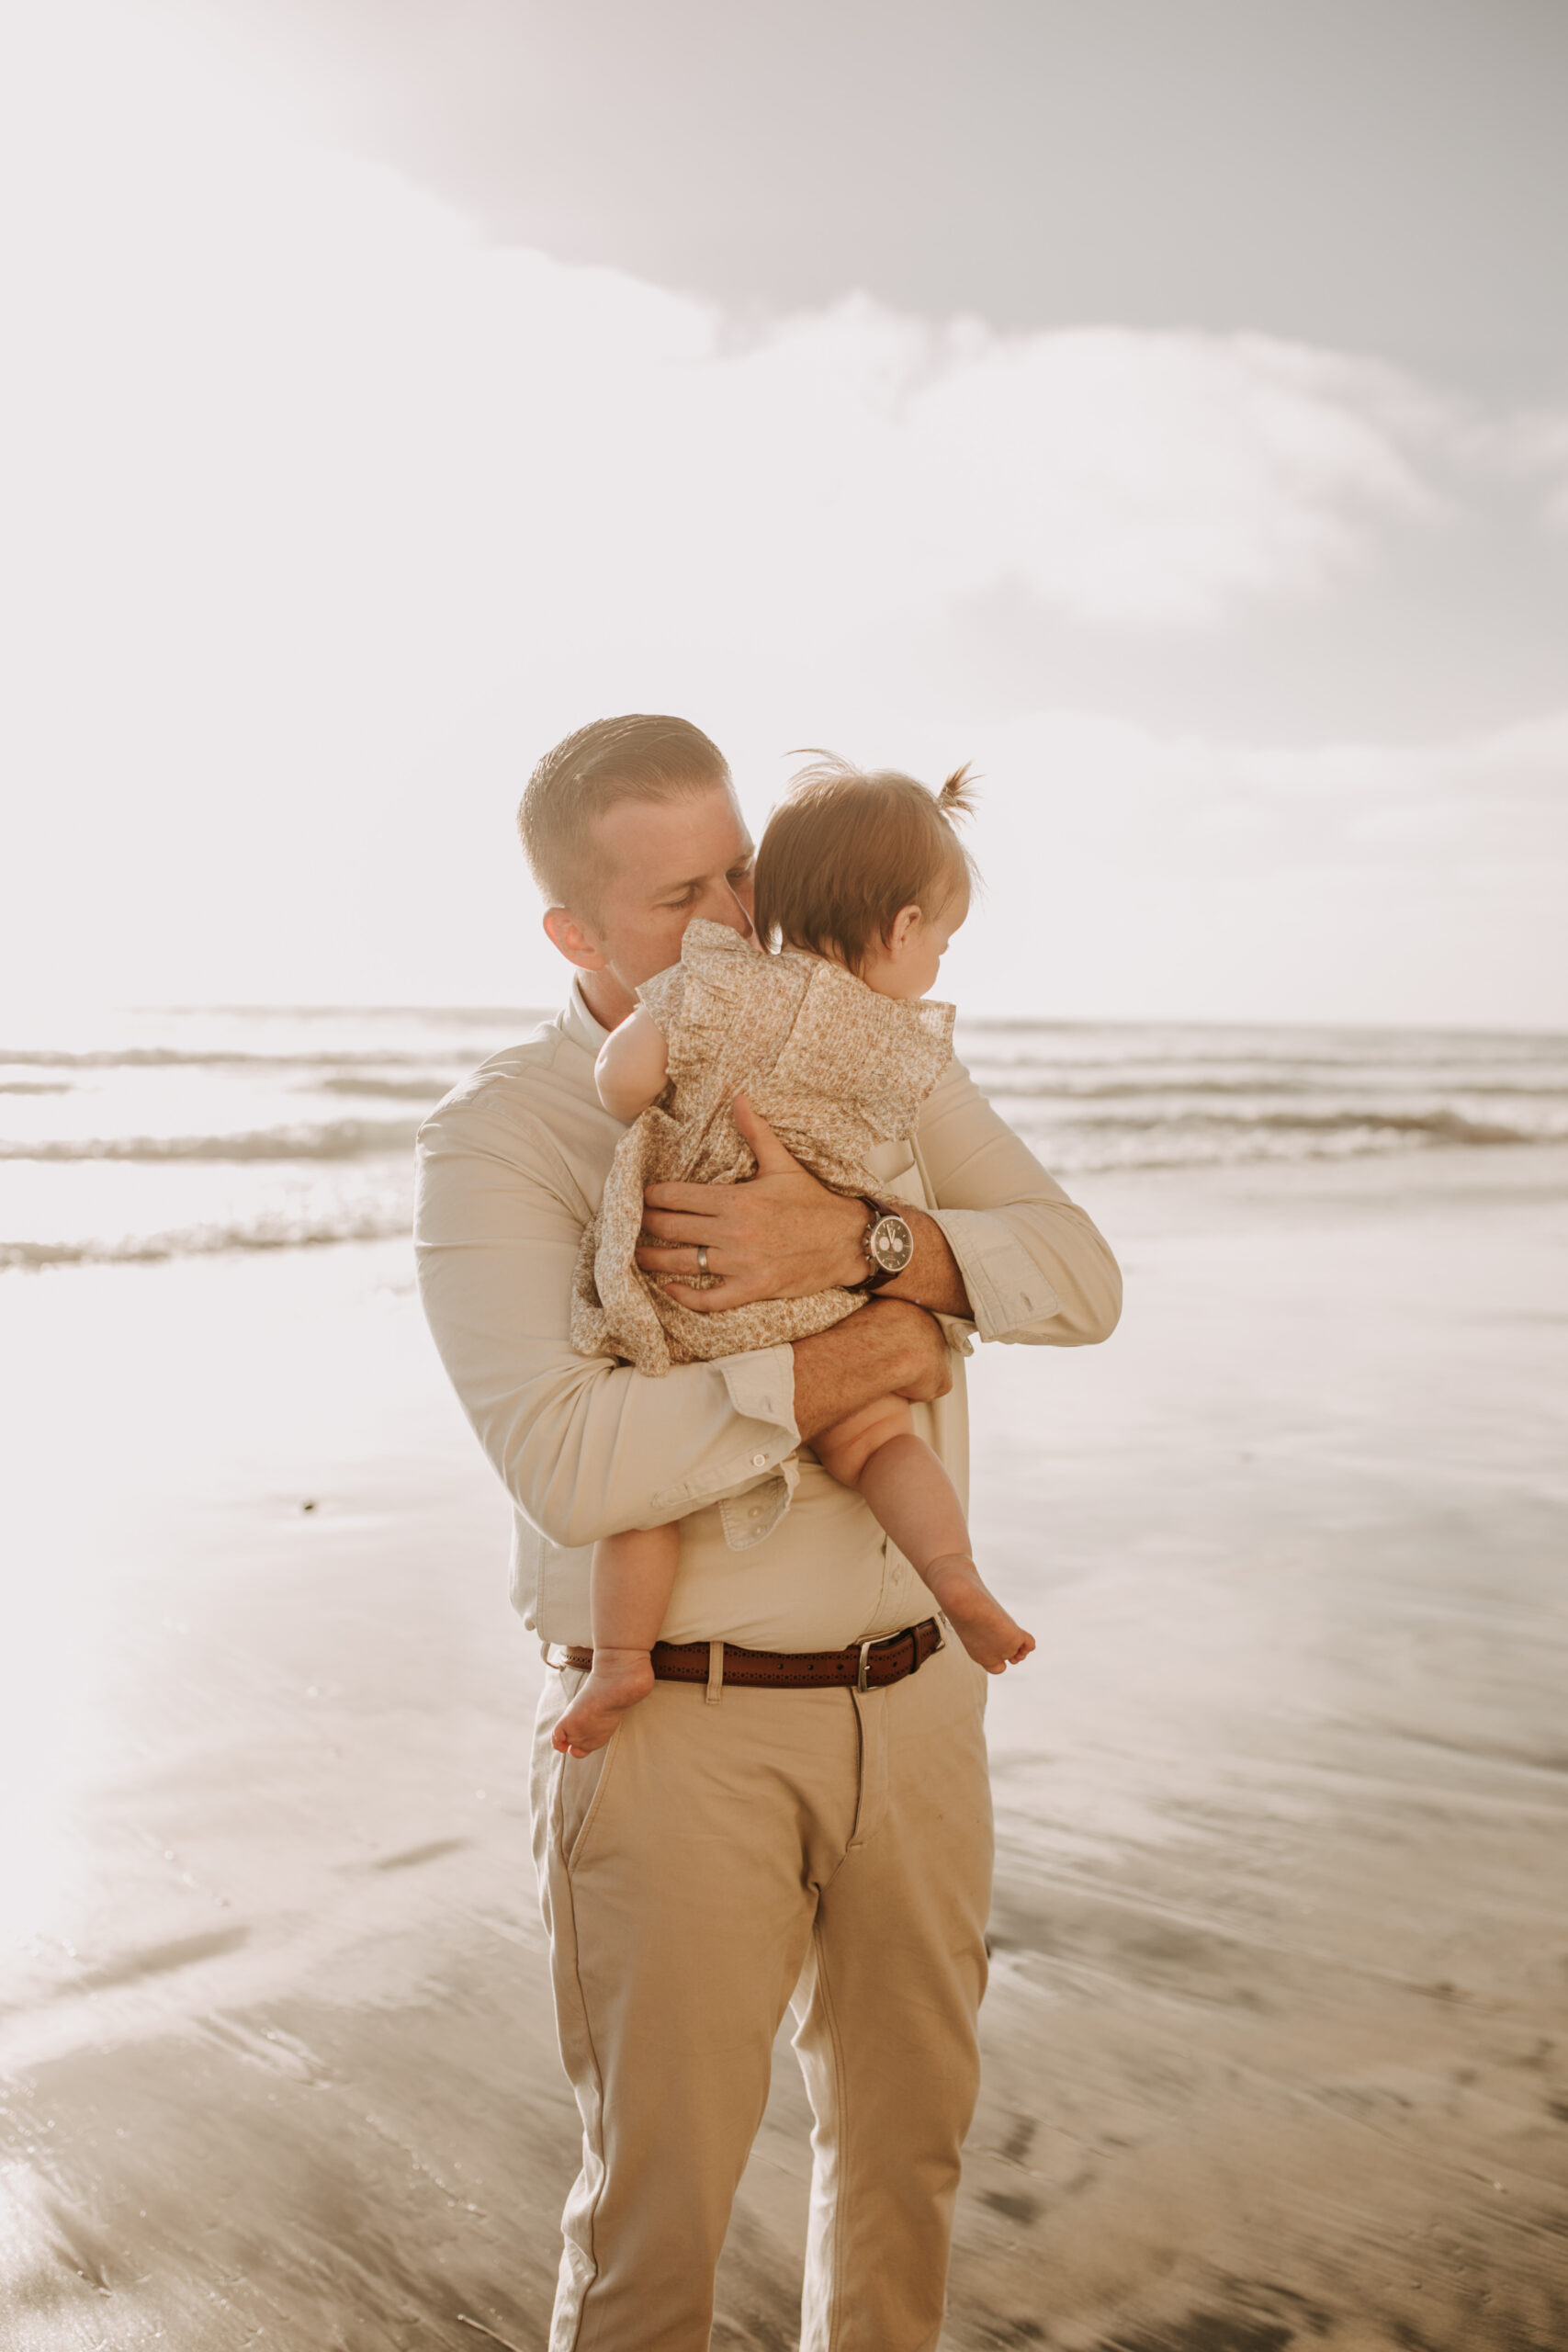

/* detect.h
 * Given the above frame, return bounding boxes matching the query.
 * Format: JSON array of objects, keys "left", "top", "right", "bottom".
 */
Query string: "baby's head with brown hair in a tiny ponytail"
[{"left": 757, "top": 755, "right": 976, "bottom": 997}]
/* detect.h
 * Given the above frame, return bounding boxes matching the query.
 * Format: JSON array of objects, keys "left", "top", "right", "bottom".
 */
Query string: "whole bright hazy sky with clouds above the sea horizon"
[{"left": 0, "top": 0, "right": 1568, "bottom": 1025}]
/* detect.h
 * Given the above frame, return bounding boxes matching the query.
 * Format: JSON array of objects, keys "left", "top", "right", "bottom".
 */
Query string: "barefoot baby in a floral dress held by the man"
[{"left": 555, "top": 762, "right": 1034, "bottom": 1757}]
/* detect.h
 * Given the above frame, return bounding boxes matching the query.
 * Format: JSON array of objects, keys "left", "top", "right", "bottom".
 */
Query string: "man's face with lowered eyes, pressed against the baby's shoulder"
[{"left": 581, "top": 783, "right": 757, "bottom": 995}]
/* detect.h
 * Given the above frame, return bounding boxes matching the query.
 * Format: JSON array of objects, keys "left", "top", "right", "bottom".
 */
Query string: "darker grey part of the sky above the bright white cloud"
[{"left": 200, "top": 0, "right": 1568, "bottom": 395}]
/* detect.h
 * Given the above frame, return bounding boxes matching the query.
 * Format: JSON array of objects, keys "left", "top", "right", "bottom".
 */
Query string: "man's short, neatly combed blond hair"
[{"left": 517, "top": 713, "right": 731, "bottom": 912}]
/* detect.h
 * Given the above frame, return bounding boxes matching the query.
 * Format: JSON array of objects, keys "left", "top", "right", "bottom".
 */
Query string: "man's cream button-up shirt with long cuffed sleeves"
[{"left": 413, "top": 986, "right": 1122, "bottom": 1649}]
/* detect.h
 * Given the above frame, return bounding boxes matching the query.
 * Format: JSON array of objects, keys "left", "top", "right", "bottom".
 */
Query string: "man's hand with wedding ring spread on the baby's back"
[{"left": 637, "top": 1093, "right": 870, "bottom": 1315}]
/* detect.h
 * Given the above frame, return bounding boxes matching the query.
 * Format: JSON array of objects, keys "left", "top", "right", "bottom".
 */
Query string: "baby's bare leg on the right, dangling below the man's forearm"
[{"left": 811, "top": 1397, "right": 1034, "bottom": 1675}]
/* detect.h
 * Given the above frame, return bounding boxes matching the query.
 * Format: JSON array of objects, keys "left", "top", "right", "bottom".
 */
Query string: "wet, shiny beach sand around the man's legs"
[{"left": 0, "top": 1150, "right": 1568, "bottom": 2352}]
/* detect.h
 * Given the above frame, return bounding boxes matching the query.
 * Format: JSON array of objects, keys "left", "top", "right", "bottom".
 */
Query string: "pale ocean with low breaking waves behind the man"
[{"left": 0, "top": 1007, "right": 1568, "bottom": 1270}]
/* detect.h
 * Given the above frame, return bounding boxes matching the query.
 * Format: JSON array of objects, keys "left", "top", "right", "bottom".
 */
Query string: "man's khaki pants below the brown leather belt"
[{"left": 534, "top": 1639, "right": 992, "bottom": 2352}]
